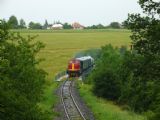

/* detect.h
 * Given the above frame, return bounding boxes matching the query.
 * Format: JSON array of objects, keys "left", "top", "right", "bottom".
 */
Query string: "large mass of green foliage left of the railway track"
[{"left": 0, "top": 20, "right": 48, "bottom": 120}]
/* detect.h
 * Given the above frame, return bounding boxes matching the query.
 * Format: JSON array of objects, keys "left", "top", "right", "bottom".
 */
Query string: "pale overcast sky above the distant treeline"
[{"left": 0, "top": 0, "right": 142, "bottom": 25}]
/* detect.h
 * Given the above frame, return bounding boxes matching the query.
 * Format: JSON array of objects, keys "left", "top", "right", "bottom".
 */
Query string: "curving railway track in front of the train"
[{"left": 61, "top": 80, "right": 86, "bottom": 120}]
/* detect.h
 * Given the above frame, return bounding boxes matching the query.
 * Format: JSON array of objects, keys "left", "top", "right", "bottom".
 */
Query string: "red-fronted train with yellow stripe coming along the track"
[{"left": 67, "top": 56, "right": 94, "bottom": 78}]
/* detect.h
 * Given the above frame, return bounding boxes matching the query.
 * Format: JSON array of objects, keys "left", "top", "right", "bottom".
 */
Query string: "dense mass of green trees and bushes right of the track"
[{"left": 88, "top": 0, "right": 160, "bottom": 120}]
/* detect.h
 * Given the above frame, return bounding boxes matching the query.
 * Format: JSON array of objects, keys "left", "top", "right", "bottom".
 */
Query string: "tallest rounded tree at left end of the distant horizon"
[{"left": 8, "top": 16, "right": 18, "bottom": 29}]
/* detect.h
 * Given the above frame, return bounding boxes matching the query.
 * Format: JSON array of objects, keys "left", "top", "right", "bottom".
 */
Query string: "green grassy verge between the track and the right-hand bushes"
[{"left": 79, "top": 83, "right": 146, "bottom": 120}]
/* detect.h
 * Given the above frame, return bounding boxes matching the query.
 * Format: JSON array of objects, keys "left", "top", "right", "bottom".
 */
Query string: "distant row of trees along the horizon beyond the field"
[{"left": 2, "top": 15, "right": 124, "bottom": 29}]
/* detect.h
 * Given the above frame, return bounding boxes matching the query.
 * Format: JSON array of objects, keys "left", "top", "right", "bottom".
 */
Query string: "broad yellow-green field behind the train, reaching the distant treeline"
[{"left": 20, "top": 30, "right": 130, "bottom": 80}]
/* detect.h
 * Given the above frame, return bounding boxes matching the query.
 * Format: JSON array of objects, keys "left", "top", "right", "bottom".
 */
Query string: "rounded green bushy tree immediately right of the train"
[{"left": 89, "top": 45, "right": 122, "bottom": 100}]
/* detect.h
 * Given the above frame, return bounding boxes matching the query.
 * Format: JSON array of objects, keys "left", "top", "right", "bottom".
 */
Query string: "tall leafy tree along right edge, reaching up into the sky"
[{"left": 125, "top": 0, "right": 160, "bottom": 120}]
